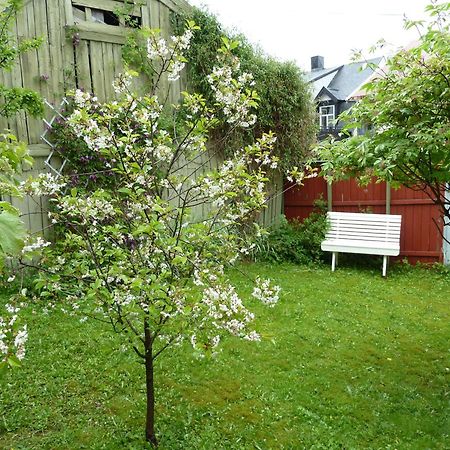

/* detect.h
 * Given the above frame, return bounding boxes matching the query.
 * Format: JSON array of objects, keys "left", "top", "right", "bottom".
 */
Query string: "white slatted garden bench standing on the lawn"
[{"left": 321, "top": 212, "right": 402, "bottom": 277}]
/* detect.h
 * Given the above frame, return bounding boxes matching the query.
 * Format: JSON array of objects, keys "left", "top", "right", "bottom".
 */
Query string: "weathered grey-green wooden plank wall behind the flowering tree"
[{"left": 0, "top": 0, "right": 282, "bottom": 232}]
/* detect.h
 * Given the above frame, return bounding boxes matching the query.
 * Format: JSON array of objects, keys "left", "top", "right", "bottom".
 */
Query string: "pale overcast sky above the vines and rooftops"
[{"left": 189, "top": 0, "right": 430, "bottom": 71}]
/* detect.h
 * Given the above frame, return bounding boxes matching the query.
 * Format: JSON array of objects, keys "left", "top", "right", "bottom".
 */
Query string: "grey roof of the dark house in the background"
[{"left": 305, "top": 57, "right": 383, "bottom": 101}]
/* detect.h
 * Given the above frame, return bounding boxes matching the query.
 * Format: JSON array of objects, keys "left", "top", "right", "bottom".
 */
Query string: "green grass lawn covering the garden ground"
[{"left": 0, "top": 264, "right": 450, "bottom": 449}]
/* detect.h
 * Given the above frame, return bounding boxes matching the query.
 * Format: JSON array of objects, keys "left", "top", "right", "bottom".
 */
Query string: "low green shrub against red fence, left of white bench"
[{"left": 252, "top": 200, "right": 328, "bottom": 264}]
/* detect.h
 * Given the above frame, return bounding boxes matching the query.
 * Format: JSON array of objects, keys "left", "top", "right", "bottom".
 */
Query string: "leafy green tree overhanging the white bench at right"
[{"left": 318, "top": 2, "right": 450, "bottom": 227}]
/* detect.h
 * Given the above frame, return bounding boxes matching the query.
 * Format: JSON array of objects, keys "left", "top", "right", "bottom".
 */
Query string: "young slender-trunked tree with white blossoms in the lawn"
[{"left": 29, "top": 23, "right": 292, "bottom": 445}]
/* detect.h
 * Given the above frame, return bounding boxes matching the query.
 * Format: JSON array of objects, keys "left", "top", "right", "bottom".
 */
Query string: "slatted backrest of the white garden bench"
[{"left": 325, "top": 211, "right": 402, "bottom": 244}]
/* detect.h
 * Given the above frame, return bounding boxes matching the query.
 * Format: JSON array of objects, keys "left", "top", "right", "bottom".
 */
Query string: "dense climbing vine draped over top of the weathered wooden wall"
[{"left": 173, "top": 8, "right": 316, "bottom": 169}]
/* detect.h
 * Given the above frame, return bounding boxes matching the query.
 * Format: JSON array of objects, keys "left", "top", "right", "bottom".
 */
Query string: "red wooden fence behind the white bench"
[{"left": 284, "top": 177, "right": 443, "bottom": 264}]
